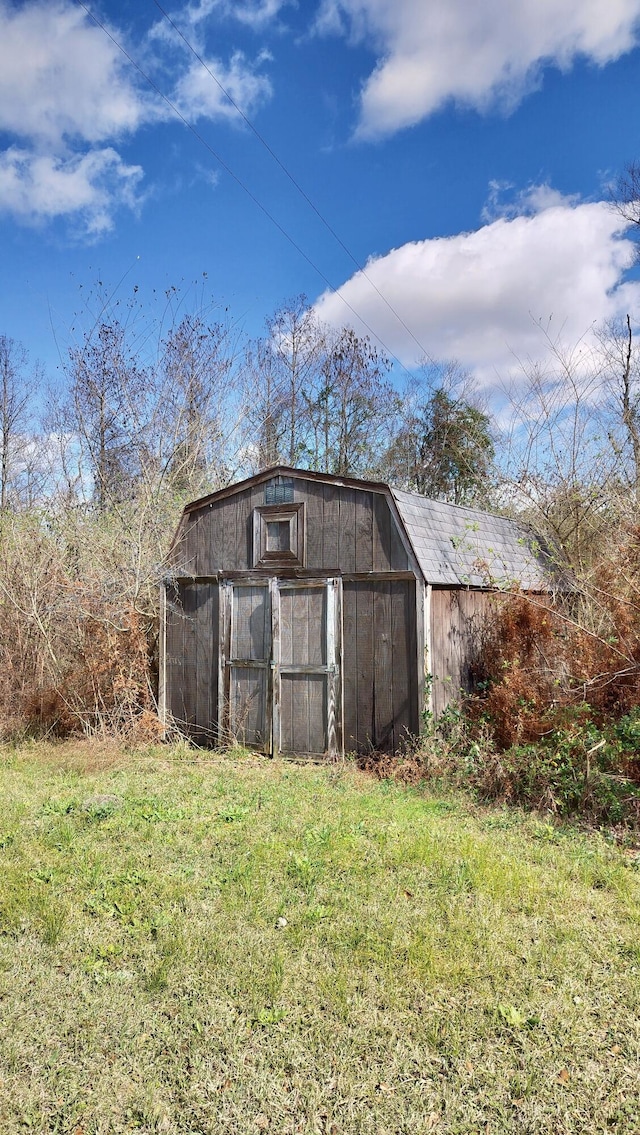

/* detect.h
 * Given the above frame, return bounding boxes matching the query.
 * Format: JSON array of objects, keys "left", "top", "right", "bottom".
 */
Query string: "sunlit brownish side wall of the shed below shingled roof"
[{"left": 428, "top": 588, "right": 495, "bottom": 716}]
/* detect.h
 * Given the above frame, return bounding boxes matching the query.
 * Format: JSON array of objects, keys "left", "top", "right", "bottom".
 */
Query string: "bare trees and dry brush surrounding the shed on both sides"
[{"left": 0, "top": 289, "right": 640, "bottom": 822}]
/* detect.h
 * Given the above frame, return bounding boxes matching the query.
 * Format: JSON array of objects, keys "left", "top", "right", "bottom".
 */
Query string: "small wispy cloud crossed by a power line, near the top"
[{"left": 175, "top": 51, "right": 271, "bottom": 119}]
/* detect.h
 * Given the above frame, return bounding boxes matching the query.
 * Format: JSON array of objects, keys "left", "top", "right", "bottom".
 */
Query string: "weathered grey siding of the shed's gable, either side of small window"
[{"left": 171, "top": 478, "right": 411, "bottom": 575}]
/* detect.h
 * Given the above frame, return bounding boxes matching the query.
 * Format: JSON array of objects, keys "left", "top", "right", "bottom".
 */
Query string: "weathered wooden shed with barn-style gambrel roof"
[{"left": 160, "top": 466, "right": 545, "bottom": 758}]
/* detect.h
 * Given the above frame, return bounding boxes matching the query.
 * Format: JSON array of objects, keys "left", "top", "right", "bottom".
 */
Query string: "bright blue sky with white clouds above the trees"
[{"left": 0, "top": 0, "right": 640, "bottom": 394}]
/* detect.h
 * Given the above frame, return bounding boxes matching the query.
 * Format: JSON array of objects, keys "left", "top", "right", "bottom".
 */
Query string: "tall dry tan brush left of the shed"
[{"left": 0, "top": 508, "right": 173, "bottom": 740}]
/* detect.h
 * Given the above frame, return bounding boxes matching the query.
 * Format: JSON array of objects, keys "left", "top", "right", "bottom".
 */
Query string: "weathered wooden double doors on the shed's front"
[{"left": 219, "top": 578, "right": 342, "bottom": 757}]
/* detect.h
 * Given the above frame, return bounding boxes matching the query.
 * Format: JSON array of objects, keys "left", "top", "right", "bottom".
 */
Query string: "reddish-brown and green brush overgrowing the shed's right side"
[{"left": 447, "top": 527, "right": 640, "bottom": 824}]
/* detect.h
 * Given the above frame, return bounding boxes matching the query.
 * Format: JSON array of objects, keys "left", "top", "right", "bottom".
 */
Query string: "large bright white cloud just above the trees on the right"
[{"left": 317, "top": 186, "right": 640, "bottom": 387}]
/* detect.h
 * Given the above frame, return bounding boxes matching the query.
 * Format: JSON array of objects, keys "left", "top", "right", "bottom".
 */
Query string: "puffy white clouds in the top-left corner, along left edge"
[{"left": 0, "top": 0, "right": 152, "bottom": 232}]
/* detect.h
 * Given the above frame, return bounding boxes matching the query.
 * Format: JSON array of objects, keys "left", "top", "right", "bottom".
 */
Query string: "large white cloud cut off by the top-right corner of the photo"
[{"left": 317, "top": 0, "right": 640, "bottom": 137}]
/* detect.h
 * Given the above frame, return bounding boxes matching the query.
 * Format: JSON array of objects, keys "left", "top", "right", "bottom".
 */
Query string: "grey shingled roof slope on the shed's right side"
[{"left": 391, "top": 489, "right": 550, "bottom": 591}]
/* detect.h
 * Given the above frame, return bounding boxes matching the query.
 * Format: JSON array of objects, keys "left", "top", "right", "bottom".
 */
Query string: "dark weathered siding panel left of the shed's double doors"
[{"left": 165, "top": 580, "right": 219, "bottom": 745}]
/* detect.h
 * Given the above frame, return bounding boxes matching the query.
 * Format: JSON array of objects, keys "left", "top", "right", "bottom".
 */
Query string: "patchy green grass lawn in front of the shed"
[{"left": 0, "top": 746, "right": 640, "bottom": 1135}]
